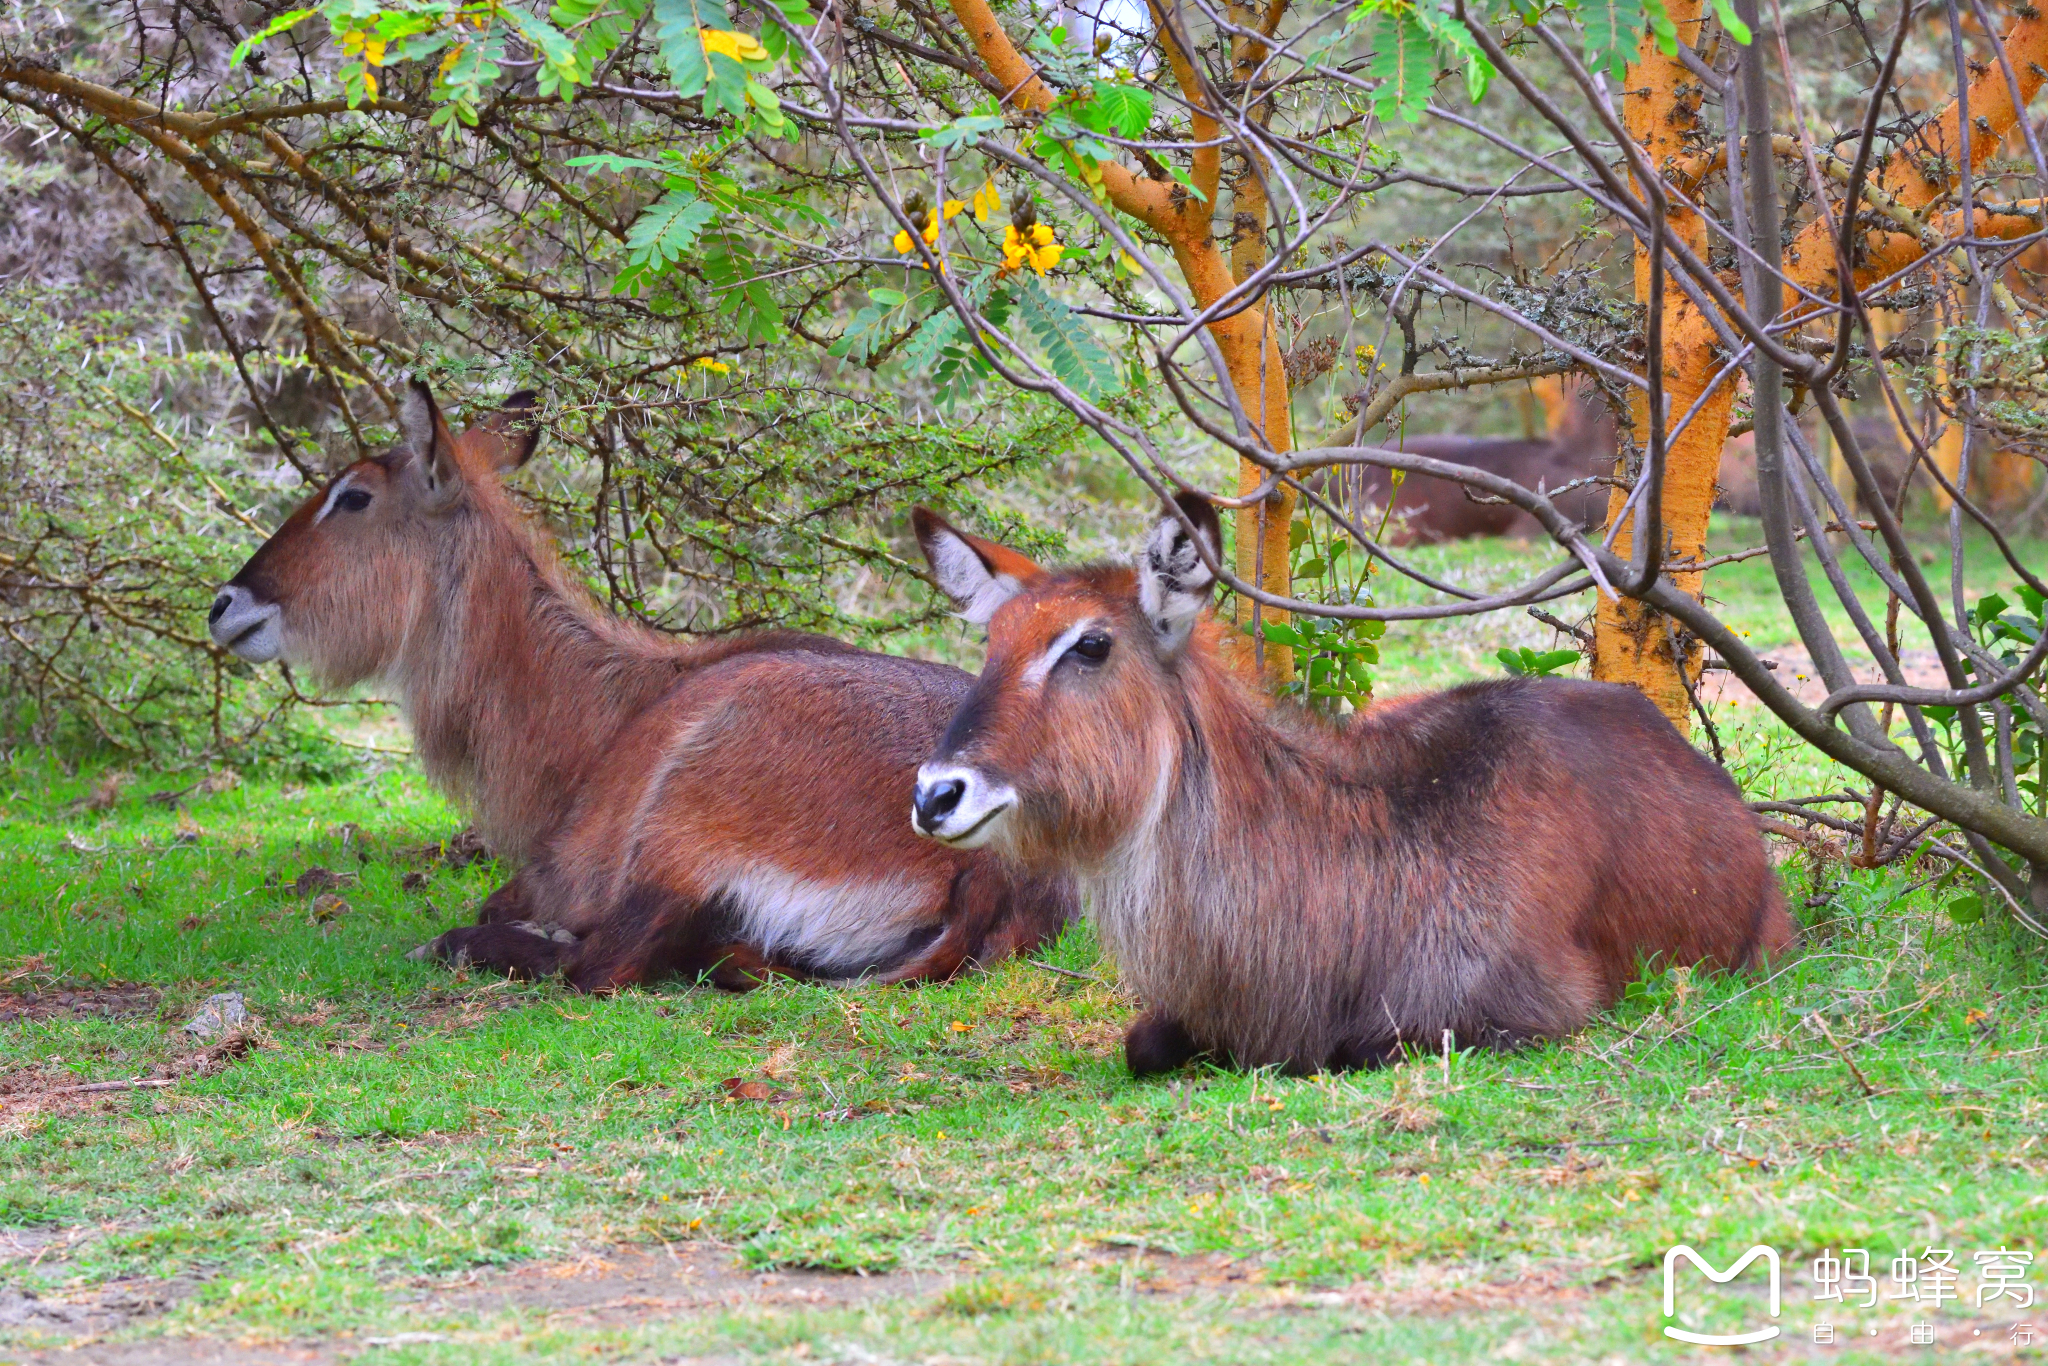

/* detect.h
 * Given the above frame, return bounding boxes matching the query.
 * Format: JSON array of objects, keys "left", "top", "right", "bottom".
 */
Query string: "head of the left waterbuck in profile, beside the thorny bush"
[{"left": 207, "top": 381, "right": 539, "bottom": 686}]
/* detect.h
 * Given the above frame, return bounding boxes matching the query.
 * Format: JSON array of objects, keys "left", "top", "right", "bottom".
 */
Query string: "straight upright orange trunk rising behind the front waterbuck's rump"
[{"left": 1593, "top": 0, "right": 1735, "bottom": 731}]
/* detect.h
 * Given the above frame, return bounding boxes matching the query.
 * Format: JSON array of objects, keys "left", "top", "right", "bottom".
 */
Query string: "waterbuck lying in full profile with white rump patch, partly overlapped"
[{"left": 211, "top": 383, "right": 1073, "bottom": 989}]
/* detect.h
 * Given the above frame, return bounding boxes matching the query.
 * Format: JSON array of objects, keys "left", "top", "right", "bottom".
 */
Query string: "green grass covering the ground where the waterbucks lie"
[{"left": 0, "top": 518, "right": 2048, "bottom": 1364}]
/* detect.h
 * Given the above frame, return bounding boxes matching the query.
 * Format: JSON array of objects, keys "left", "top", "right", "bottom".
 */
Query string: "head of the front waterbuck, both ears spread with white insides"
[{"left": 911, "top": 494, "right": 1221, "bottom": 864}]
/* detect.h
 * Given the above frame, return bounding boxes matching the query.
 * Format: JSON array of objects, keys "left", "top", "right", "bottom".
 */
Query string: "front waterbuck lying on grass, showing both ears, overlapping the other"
[{"left": 911, "top": 496, "right": 1792, "bottom": 1075}]
